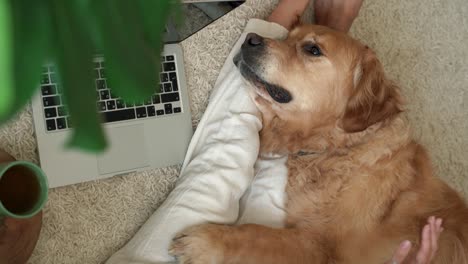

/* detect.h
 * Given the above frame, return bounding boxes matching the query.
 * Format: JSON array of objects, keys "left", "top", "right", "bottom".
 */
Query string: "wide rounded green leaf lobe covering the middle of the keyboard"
[{"left": 91, "top": 0, "right": 175, "bottom": 101}]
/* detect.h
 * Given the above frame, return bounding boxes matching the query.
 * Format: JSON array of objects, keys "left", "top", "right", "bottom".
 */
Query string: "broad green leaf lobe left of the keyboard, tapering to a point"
[{"left": 9, "top": 0, "right": 51, "bottom": 120}]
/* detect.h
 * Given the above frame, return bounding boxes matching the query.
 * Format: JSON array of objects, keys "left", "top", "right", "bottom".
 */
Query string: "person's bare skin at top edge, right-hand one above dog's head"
[{"left": 314, "top": 0, "right": 363, "bottom": 32}]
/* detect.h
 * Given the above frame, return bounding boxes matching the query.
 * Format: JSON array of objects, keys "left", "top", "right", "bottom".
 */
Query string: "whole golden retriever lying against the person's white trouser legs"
[{"left": 170, "top": 25, "right": 468, "bottom": 264}]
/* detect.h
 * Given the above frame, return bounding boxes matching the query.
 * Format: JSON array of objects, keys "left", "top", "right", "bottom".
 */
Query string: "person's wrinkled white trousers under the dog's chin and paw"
[{"left": 107, "top": 19, "right": 287, "bottom": 264}]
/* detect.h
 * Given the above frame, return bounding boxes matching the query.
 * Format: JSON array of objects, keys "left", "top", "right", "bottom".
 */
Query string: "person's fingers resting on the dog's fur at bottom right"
[{"left": 385, "top": 216, "right": 444, "bottom": 264}]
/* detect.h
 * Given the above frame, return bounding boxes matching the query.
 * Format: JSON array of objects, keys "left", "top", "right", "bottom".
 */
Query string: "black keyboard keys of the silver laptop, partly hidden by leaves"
[{"left": 41, "top": 55, "right": 182, "bottom": 131}]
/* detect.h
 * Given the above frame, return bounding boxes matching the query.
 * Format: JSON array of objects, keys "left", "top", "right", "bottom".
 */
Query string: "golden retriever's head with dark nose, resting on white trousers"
[{"left": 234, "top": 25, "right": 401, "bottom": 152}]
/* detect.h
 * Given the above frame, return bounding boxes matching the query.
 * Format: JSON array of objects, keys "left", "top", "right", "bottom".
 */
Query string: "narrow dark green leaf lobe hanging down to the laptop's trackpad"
[{"left": 50, "top": 0, "right": 106, "bottom": 152}]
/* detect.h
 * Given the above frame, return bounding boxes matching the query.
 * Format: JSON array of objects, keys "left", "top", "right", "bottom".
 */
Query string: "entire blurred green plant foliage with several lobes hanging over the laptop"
[{"left": 0, "top": 0, "right": 178, "bottom": 152}]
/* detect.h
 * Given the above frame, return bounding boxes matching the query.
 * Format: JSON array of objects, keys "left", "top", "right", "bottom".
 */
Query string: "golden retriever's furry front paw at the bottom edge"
[{"left": 169, "top": 224, "right": 226, "bottom": 264}]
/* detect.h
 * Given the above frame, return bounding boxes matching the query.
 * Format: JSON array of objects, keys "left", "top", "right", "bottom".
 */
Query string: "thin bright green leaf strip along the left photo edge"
[{"left": 0, "top": 0, "right": 14, "bottom": 120}]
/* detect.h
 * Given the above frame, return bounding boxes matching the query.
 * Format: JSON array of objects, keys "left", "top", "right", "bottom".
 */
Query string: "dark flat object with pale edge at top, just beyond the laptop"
[{"left": 164, "top": 0, "right": 245, "bottom": 43}]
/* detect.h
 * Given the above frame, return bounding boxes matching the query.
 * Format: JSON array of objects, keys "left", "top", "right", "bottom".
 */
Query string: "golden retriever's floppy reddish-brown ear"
[{"left": 341, "top": 47, "right": 402, "bottom": 133}]
